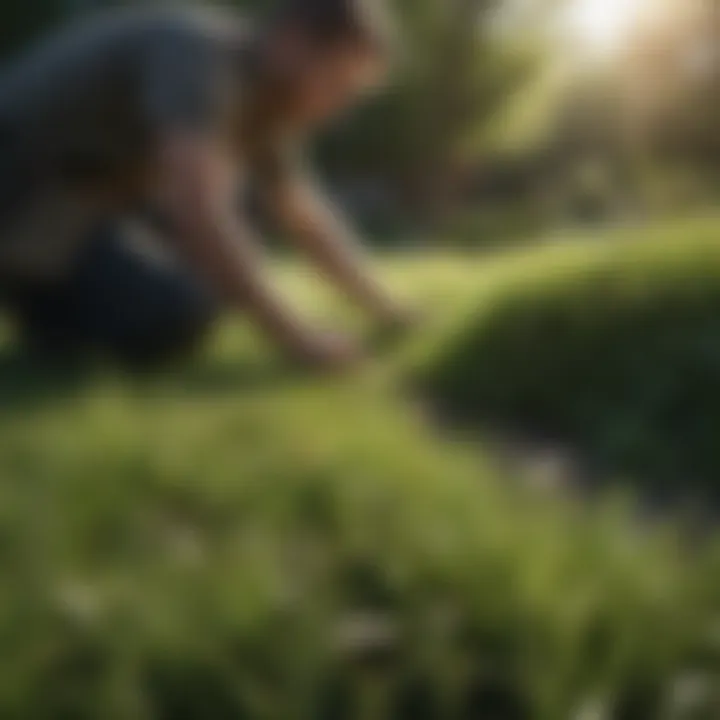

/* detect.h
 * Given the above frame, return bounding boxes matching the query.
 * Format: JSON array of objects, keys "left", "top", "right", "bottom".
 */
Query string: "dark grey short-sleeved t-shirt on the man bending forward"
[{"left": 0, "top": 6, "right": 294, "bottom": 270}]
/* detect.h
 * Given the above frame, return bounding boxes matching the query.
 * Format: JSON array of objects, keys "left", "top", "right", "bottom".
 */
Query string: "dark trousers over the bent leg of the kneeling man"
[{"left": 0, "top": 222, "right": 218, "bottom": 365}]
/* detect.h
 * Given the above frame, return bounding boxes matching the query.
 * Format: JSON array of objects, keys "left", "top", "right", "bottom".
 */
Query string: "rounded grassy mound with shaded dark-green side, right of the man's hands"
[{"left": 425, "top": 221, "right": 720, "bottom": 500}]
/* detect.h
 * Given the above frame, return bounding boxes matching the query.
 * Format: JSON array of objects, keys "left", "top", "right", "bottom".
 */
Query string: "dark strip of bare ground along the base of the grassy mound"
[{"left": 420, "top": 391, "right": 720, "bottom": 520}]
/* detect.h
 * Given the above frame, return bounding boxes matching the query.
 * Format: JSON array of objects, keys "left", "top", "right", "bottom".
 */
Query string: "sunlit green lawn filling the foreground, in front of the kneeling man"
[{"left": 0, "top": 233, "right": 720, "bottom": 720}]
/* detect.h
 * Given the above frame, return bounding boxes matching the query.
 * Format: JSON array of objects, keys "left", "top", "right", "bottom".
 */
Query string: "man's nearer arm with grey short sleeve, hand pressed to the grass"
[{"left": 141, "top": 33, "right": 354, "bottom": 366}]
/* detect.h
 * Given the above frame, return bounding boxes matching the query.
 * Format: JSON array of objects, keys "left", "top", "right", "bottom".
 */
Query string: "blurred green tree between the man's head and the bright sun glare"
[{"left": 318, "top": 0, "right": 535, "bottom": 215}]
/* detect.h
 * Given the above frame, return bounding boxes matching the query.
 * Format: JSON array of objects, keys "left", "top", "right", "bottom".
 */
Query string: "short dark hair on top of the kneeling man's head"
[{"left": 280, "top": 0, "right": 394, "bottom": 53}]
